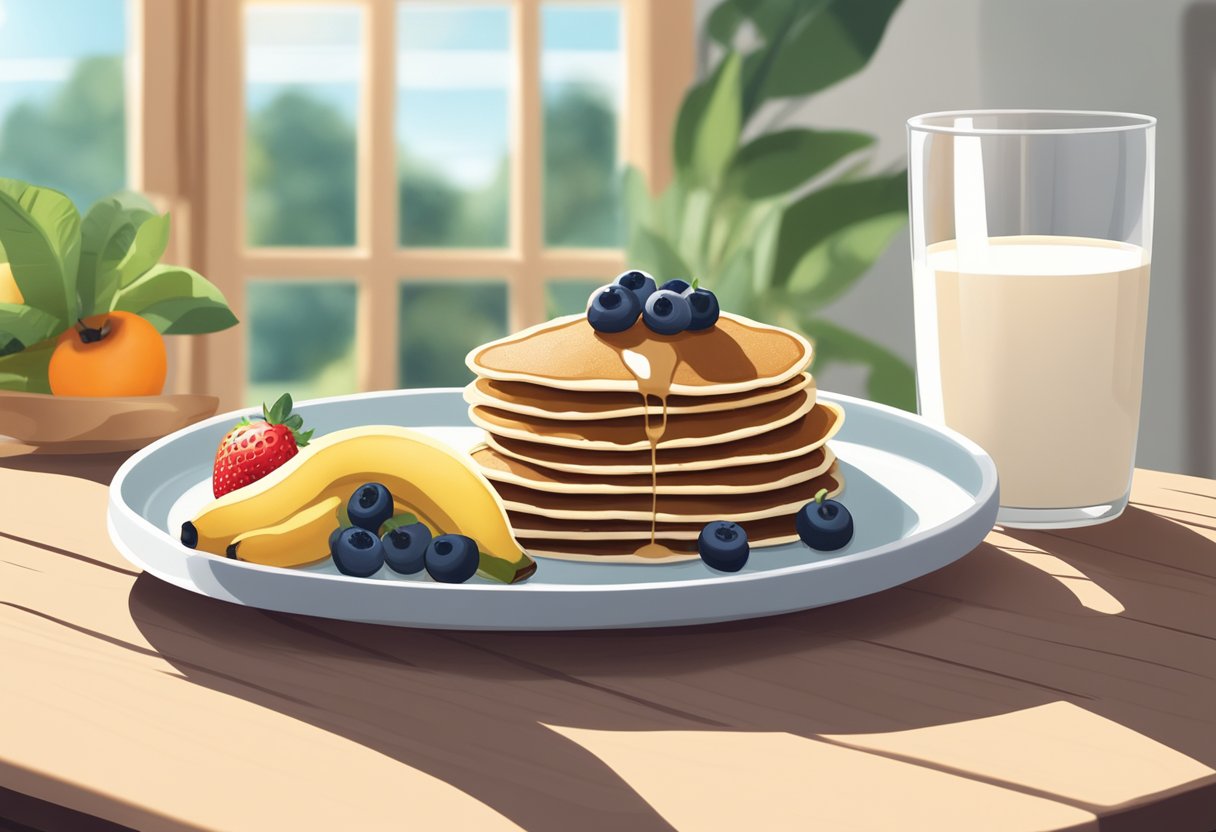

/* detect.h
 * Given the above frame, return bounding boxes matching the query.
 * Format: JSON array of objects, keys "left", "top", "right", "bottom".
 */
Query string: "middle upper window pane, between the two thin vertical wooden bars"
[{"left": 396, "top": 2, "right": 514, "bottom": 247}]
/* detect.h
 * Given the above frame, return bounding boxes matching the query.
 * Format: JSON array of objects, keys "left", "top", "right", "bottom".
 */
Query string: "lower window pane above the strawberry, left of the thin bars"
[{"left": 244, "top": 279, "right": 358, "bottom": 405}]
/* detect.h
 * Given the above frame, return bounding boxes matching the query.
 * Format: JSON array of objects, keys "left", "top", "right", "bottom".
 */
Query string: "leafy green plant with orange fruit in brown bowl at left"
[{"left": 0, "top": 179, "right": 237, "bottom": 446}]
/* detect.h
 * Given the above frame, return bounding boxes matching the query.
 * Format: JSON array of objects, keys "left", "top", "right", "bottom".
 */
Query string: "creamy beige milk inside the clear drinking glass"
[{"left": 913, "top": 236, "right": 1149, "bottom": 508}]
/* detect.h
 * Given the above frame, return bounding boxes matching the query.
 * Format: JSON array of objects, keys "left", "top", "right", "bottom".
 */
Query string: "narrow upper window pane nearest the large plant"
[{"left": 541, "top": 4, "right": 624, "bottom": 247}]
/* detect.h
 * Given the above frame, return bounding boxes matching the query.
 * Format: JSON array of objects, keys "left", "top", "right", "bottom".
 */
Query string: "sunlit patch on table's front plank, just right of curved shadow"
[{"left": 546, "top": 725, "right": 1097, "bottom": 832}]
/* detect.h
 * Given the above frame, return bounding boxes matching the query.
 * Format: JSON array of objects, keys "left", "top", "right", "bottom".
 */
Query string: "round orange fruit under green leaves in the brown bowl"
[{"left": 49, "top": 311, "right": 168, "bottom": 397}]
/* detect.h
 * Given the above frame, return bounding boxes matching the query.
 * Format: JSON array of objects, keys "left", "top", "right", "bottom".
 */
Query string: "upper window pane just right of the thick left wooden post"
[{"left": 246, "top": 6, "right": 362, "bottom": 246}]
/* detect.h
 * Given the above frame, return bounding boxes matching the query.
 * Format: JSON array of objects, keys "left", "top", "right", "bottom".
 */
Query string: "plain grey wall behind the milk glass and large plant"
[{"left": 698, "top": 0, "right": 1216, "bottom": 476}]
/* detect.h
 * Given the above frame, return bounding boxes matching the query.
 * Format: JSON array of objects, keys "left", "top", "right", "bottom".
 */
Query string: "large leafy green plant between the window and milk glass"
[{"left": 625, "top": 0, "right": 916, "bottom": 410}]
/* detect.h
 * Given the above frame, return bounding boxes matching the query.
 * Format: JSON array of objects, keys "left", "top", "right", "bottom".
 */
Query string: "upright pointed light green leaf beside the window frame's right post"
[{"left": 675, "top": 52, "right": 743, "bottom": 186}]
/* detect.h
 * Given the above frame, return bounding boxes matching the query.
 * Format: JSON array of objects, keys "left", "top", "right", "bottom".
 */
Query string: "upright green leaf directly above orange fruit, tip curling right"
[{"left": 77, "top": 191, "right": 156, "bottom": 316}]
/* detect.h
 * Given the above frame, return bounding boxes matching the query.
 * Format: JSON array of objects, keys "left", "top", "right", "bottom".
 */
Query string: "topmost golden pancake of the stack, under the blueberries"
[{"left": 465, "top": 313, "right": 812, "bottom": 395}]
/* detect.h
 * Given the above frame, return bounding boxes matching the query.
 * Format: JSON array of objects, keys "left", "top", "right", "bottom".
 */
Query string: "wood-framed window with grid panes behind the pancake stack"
[{"left": 130, "top": 0, "right": 693, "bottom": 406}]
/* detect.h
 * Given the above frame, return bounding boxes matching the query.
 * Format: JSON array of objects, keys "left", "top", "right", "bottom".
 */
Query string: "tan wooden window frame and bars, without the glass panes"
[{"left": 131, "top": 0, "right": 696, "bottom": 407}]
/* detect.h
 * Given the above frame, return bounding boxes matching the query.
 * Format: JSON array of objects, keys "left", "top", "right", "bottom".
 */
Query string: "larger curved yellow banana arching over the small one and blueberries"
[{"left": 181, "top": 425, "right": 536, "bottom": 583}]
